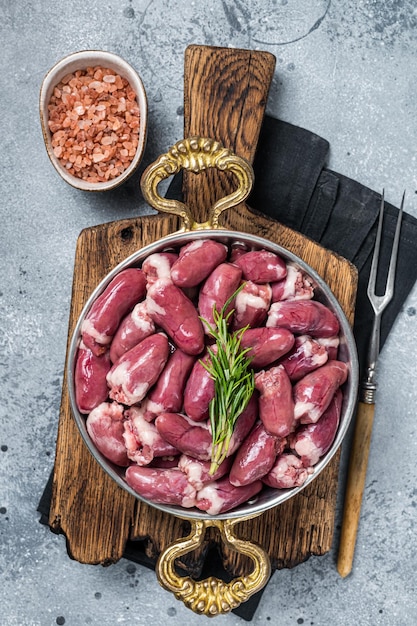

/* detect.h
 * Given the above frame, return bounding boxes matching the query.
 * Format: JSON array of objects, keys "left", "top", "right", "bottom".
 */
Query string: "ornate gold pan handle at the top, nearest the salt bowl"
[{"left": 141, "top": 137, "right": 254, "bottom": 230}]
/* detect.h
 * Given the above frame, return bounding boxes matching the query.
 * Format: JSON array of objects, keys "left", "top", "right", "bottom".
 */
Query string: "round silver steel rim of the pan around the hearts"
[{"left": 67, "top": 229, "right": 359, "bottom": 520}]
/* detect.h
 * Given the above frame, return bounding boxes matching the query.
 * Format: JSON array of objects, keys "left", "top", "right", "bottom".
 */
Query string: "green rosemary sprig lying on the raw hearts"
[{"left": 200, "top": 285, "right": 255, "bottom": 474}]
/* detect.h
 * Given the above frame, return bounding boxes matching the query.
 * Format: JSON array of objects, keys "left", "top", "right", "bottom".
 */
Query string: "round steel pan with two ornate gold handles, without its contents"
[{"left": 68, "top": 137, "right": 358, "bottom": 616}]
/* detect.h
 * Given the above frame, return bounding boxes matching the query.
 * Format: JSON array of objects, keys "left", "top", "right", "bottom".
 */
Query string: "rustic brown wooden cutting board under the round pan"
[{"left": 49, "top": 46, "right": 357, "bottom": 576}]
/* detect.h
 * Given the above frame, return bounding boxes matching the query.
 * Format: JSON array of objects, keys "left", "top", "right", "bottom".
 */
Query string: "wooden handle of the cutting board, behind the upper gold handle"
[{"left": 183, "top": 45, "right": 276, "bottom": 223}]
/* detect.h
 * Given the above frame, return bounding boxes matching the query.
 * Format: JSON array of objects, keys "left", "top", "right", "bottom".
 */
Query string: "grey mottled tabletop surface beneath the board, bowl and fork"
[{"left": 0, "top": 0, "right": 417, "bottom": 626}]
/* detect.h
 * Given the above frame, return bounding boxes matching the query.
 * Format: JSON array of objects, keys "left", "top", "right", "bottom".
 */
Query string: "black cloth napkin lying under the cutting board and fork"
[{"left": 38, "top": 116, "right": 417, "bottom": 621}]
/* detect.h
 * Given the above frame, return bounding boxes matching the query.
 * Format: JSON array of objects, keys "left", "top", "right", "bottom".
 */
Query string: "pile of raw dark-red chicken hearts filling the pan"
[{"left": 74, "top": 238, "right": 348, "bottom": 515}]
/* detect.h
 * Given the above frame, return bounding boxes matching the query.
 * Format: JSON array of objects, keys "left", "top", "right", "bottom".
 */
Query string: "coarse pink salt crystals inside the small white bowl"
[{"left": 48, "top": 66, "right": 140, "bottom": 183}]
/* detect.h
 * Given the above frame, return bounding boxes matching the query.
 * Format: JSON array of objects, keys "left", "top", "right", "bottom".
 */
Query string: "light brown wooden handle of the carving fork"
[{"left": 337, "top": 402, "right": 375, "bottom": 578}]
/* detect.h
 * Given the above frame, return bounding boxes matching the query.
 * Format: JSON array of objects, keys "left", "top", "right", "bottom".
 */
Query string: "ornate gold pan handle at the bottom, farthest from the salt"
[{"left": 156, "top": 518, "right": 271, "bottom": 617}]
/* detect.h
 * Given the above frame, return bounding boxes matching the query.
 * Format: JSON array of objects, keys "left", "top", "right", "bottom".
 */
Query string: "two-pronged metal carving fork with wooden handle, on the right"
[{"left": 337, "top": 189, "right": 404, "bottom": 577}]
